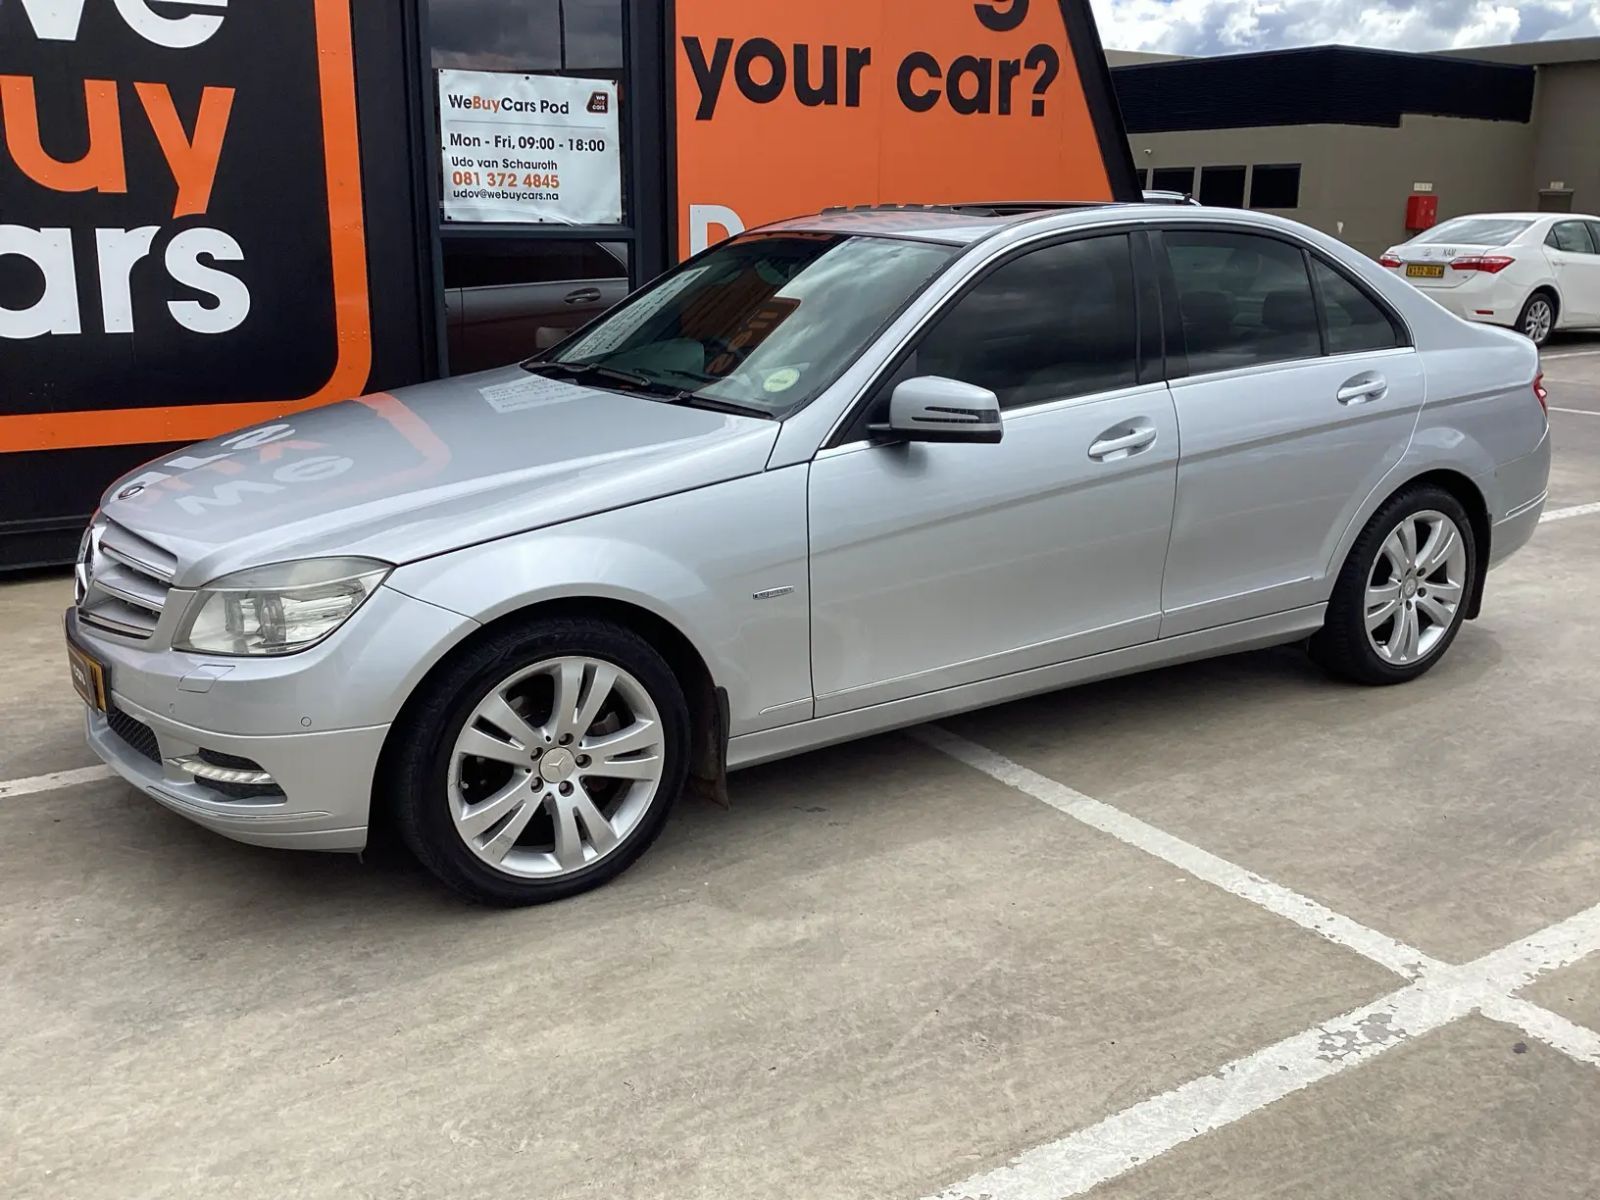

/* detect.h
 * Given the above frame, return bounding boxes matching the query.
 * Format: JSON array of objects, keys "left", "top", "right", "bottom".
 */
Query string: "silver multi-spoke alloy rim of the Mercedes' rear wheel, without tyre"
[{"left": 1363, "top": 509, "right": 1467, "bottom": 667}]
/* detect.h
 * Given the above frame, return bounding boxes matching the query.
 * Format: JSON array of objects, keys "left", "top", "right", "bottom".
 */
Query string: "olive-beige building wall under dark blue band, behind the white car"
[{"left": 1128, "top": 115, "right": 1536, "bottom": 256}]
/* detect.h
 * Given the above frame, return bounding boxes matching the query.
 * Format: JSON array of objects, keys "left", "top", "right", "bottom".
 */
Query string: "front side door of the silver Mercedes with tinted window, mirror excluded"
[{"left": 810, "top": 234, "right": 1178, "bottom": 717}]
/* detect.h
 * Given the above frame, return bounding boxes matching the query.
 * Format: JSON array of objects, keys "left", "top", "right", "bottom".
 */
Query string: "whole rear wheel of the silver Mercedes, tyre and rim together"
[{"left": 1310, "top": 485, "right": 1477, "bottom": 683}]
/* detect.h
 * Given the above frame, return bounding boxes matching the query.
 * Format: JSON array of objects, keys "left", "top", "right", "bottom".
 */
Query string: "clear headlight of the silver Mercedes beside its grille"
[{"left": 173, "top": 558, "right": 390, "bottom": 654}]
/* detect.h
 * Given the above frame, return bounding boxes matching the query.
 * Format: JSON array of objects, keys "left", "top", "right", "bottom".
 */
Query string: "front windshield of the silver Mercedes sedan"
[{"left": 544, "top": 234, "right": 957, "bottom": 416}]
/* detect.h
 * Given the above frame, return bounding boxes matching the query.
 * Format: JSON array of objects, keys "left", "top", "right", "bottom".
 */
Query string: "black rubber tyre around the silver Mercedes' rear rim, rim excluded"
[{"left": 1310, "top": 483, "right": 1478, "bottom": 686}]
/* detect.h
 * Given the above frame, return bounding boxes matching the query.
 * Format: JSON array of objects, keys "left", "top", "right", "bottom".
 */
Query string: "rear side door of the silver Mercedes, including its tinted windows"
[{"left": 1158, "top": 229, "right": 1424, "bottom": 637}]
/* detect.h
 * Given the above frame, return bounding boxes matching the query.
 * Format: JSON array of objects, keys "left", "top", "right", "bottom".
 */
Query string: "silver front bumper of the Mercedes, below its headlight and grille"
[{"left": 67, "top": 587, "right": 475, "bottom": 850}]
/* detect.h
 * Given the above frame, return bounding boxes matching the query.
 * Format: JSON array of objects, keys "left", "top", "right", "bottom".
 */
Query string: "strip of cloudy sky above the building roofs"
[{"left": 1091, "top": 0, "right": 1600, "bottom": 54}]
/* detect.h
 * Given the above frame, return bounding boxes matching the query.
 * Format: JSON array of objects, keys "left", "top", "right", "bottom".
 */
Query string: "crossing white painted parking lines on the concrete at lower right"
[{"left": 910, "top": 723, "right": 1600, "bottom": 1200}]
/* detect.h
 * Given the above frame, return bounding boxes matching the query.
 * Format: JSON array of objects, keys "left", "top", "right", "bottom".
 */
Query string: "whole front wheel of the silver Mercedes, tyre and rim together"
[{"left": 390, "top": 619, "right": 690, "bottom": 904}]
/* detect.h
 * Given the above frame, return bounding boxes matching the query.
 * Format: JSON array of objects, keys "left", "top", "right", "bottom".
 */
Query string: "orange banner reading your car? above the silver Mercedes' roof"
[{"left": 675, "top": 0, "right": 1134, "bottom": 258}]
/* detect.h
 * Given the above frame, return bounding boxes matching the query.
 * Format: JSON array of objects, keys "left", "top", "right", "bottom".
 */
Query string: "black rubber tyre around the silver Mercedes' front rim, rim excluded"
[{"left": 384, "top": 618, "right": 690, "bottom": 907}]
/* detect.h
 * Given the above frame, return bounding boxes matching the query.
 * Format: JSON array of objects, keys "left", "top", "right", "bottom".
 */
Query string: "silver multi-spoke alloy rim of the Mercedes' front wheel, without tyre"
[{"left": 448, "top": 658, "right": 666, "bottom": 880}]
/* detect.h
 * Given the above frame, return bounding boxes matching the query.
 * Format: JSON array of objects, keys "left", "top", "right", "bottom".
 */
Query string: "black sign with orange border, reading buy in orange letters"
[{"left": 0, "top": 0, "right": 371, "bottom": 453}]
